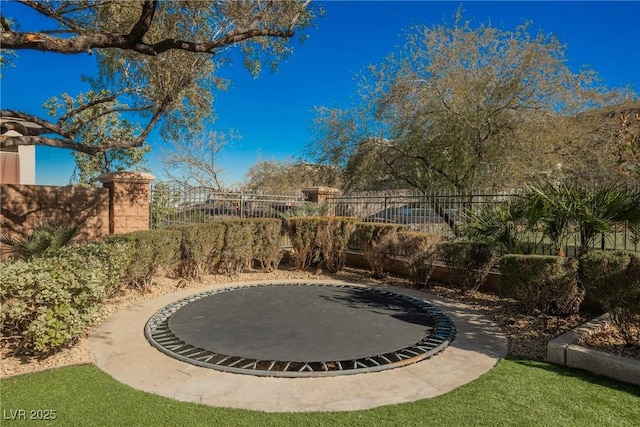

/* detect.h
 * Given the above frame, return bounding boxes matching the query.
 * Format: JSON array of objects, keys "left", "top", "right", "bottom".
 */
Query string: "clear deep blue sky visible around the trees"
[{"left": 0, "top": 0, "right": 640, "bottom": 185}]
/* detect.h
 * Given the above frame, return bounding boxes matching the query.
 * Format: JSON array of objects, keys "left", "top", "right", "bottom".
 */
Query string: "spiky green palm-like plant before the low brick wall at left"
[{"left": 0, "top": 221, "right": 82, "bottom": 259}]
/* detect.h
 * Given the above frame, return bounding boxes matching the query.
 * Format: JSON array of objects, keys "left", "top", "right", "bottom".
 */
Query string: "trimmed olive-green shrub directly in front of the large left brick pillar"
[{"left": 109, "top": 230, "right": 182, "bottom": 290}]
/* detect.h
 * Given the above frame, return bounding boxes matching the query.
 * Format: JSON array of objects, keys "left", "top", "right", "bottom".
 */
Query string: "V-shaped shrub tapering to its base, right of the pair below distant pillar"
[{"left": 356, "top": 222, "right": 406, "bottom": 279}]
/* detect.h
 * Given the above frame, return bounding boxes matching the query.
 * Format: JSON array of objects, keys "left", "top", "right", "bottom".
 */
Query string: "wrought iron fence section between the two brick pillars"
[{"left": 149, "top": 182, "right": 307, "bottom": 228}]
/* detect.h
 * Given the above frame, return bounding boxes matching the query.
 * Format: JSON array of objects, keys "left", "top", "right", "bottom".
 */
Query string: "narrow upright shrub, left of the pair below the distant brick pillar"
[{"left": 287, "top": 216, "right": 321, "bottom": 270}]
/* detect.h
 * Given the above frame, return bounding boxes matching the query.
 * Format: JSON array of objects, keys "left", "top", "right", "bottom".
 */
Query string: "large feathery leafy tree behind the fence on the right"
[{"left": 310, "top": 12, "right": 635, "bottom": 191}]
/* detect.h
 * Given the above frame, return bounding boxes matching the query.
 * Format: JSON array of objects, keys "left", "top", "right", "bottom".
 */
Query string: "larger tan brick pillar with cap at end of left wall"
[{"left": 98, "top": 172, "right": 154, "bottom": 234}]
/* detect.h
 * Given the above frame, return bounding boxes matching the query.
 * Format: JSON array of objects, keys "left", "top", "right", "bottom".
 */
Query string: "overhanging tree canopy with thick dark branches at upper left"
[{"left": 0, "top": 0, "right": 316, "bottom": 155}]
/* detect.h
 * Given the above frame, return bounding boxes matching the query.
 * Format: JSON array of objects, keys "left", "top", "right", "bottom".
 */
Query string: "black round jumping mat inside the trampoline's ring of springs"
[{"left": 169, "top": 285, "right": 434, "bottom": 362}]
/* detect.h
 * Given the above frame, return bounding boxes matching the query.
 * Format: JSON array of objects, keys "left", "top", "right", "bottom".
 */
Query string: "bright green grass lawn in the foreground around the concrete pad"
[{"left": 0, "top": 358, "right": 640, "bottom": 427}]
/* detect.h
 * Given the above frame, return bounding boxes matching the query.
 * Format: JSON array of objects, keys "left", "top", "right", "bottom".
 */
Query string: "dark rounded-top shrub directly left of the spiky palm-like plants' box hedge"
[{"left": 436, "top": 241, "right": 496, "bottom": 293}]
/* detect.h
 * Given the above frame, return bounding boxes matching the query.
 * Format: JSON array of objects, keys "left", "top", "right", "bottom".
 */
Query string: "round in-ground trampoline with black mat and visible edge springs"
[{"left": 145, "top": 282, "right": 455, "bottom": 377}]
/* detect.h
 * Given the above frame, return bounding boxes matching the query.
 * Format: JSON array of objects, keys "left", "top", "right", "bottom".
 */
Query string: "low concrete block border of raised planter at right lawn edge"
[{"left": 547, "top": 313, "right": 640, "bottom": 385}]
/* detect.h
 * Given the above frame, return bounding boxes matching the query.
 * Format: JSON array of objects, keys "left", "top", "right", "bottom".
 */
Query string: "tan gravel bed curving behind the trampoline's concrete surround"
[{"left": 0, "top": 266, "right": 640, "bottom": 377}]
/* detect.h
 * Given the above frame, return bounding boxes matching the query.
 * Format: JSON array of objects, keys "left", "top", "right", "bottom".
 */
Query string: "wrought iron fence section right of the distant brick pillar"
[{"left": 327, "top": 190, "right": 640, "bottom": 256}]
